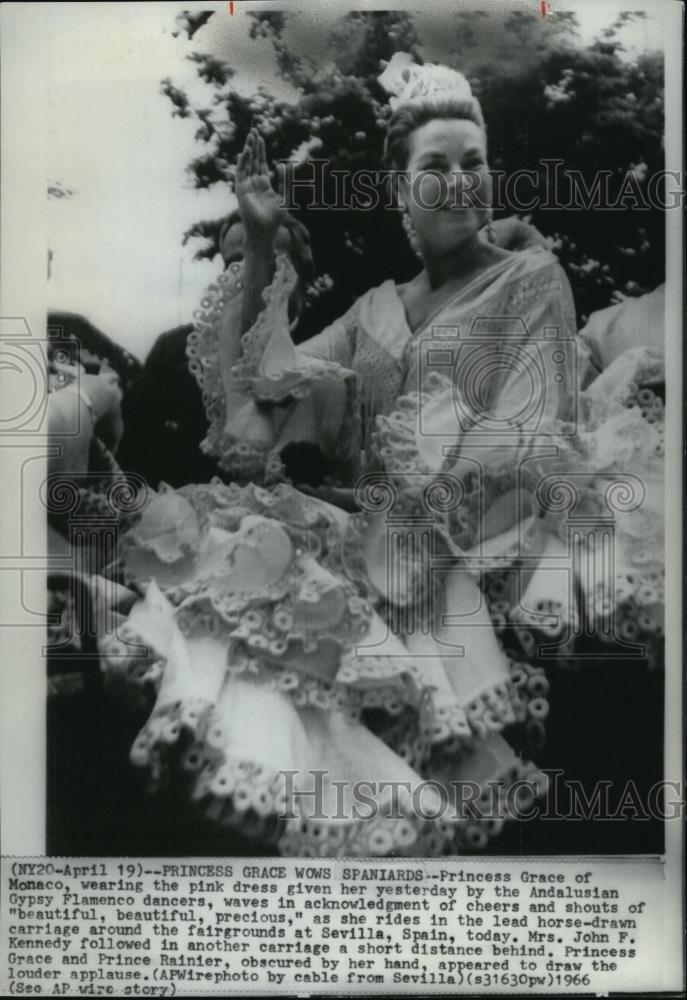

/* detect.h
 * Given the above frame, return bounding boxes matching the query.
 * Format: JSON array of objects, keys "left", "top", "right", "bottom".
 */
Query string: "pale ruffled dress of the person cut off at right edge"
[{"left": 484, "top": 285, "right": 665, "bottom": 669}]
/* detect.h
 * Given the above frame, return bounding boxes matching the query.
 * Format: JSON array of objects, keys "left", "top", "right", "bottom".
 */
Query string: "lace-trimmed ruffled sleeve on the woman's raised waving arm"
[{"left": 187, "top": 256, "right": 356, "bottom": 481}]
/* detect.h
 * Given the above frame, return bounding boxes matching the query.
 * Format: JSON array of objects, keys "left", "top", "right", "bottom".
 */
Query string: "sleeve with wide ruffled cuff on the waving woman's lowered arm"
[{"left": 375, "top": 261, "right": 576, "bottom": 554}]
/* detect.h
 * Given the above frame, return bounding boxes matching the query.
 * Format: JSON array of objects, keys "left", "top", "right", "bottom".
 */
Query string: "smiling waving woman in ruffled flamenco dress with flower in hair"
[{"left": 101, "top": 60, "right": 660, "bottom": 855}]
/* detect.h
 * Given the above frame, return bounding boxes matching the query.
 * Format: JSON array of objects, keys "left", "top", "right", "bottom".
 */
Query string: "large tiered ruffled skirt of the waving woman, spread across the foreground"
[{"left": 101, "top": 484, "right": 548, "bottom": 856}]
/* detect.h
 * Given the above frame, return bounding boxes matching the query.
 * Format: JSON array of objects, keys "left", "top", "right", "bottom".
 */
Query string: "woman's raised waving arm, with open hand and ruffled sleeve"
[{"left": 187, "top": 131, "right": 356, "bottom": 482}]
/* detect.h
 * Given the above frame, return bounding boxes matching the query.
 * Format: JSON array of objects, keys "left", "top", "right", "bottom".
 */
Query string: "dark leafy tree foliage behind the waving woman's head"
[{"left": 162, "top": 11, "right": 664, "bottom": 335}]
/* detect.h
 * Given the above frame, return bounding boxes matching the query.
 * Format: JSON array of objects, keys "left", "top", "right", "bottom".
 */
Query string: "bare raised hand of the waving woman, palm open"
[{"left": 234, "top": 129, "right": 286, "bottom": 241}]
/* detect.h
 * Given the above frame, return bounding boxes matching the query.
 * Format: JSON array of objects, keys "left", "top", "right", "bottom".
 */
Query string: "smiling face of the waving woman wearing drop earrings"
[{"left": 399, "top": 118, "right": 491, "bottom": 257}]
